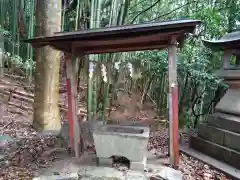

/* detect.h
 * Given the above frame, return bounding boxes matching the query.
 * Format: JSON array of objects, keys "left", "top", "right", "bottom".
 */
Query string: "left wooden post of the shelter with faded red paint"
[{"left": 65, "top": 54, "right": 82, "bottom": 158}]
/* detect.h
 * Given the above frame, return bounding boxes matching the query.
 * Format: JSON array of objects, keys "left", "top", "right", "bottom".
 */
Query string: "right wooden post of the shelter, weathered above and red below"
[{"left": 168, "top": 39, "right": 179, "bottom": 167}]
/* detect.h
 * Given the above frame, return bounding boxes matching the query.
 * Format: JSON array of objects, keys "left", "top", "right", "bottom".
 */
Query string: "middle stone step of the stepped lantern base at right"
[{"left": 198, "top": 123, "right": 240, "bottom": 152}]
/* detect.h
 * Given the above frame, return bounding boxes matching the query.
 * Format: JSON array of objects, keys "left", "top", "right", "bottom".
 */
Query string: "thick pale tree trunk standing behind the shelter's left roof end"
[{"left": 33, "top": 0, "right": 61, "bottom": 131}]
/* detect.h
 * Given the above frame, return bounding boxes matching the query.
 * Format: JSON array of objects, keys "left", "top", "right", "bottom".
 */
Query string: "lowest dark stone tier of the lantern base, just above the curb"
[{"left": 189, "top": 136, "right": 240, "bottom": 169}]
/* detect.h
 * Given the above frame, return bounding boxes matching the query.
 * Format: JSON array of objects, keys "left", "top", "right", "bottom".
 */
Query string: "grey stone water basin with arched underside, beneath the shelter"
[{"left": 93, "top": 125, "right": 149, "bottom": 170}]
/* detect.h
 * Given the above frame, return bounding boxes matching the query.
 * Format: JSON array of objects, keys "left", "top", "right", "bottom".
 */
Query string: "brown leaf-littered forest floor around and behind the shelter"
[{"left": 0, "top": 76, "right": 231, "bottom": 180}]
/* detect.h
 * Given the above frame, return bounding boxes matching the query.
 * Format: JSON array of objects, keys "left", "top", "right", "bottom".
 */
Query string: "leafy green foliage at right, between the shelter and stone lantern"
[{"left": 125, "top": 0, "right": 240, "bottom": 126}]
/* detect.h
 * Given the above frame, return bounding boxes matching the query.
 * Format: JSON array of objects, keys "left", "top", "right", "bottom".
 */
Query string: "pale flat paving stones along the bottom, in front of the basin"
[{"left": 33, "top": 166, "right": 182, "bottom": 180}]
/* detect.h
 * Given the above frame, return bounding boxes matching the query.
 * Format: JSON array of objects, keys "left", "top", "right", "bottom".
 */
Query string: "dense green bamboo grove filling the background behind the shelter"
[{"left": 0, "top": 0, "right": 240, "bottom": 129}]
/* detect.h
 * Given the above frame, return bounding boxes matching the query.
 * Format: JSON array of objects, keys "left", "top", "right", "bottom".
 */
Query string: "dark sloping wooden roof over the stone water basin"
[{"left": 24, "top": 20, "right": 201, "bottom": 55}]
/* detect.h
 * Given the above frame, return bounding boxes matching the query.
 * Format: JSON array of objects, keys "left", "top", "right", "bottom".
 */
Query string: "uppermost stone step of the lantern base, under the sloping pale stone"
[{"left": 207, "top": 112, "right": 240, "bottom": 134}]
